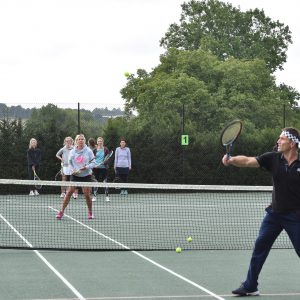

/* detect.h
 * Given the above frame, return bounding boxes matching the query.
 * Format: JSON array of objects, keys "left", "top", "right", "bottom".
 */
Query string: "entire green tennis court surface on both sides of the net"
[{"left": 0, "top": 185, "right": 300, "bottom": 300}]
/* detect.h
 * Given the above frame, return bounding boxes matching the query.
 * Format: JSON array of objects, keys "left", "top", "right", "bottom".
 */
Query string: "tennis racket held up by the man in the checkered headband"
[{"left": 221, "top": 120, "right": 243, "bottom": 160}]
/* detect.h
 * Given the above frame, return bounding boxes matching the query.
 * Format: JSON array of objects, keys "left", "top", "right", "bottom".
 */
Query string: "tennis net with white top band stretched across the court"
[{"left": 0, "top": 179, "right": 292, "bottom": 250}]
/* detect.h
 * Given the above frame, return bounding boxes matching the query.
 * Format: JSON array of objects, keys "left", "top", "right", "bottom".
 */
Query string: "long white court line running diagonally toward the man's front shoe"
[{"left": 49, "top": 206, "right": 225, "bottom": 300}]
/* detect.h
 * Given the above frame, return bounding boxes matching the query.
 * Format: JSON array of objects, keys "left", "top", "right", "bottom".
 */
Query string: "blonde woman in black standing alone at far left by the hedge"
[{"left": 27, "top": 138, "right": 42, "bottom": 196}]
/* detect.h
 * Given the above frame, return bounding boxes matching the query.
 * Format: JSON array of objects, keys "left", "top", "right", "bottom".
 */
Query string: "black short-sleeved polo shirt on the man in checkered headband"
[{"left": 256, "top": 152, "right": 300, "bottom": 213}]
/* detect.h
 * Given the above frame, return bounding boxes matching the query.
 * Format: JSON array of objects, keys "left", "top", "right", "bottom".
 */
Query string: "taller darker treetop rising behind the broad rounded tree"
[{"left": 160, "top": 0, "right": 292, "bottom": 72}]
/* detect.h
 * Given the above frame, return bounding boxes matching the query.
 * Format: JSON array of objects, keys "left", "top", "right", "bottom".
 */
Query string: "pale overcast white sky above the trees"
[{"left": 0, "top": 0, "right": 300, "bottom": 108}]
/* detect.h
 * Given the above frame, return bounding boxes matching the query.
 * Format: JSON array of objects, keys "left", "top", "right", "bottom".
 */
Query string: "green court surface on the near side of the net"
[{"left": 0, "top": 249, "right": 300, "bottom": 300}]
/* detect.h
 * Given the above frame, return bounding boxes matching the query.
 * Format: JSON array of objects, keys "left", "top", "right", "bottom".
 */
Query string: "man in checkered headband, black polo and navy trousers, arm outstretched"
[{"left": 222, "top": 127, "right": 300, "bottom": 296}]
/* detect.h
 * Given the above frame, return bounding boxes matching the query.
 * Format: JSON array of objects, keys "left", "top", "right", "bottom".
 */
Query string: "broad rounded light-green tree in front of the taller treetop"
[{"left": 121, "top": 48, "right": 293, "bottom": 132}]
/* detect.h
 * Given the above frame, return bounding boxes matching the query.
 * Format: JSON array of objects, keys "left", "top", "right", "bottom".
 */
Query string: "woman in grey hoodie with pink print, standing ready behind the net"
[{"left": 56, "top": 134, "right": 95, "bottom": 220}]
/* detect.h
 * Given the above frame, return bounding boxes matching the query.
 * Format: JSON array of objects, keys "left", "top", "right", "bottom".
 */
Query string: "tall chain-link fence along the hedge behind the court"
[{"left": 0, "top": 103, "right": 296, "bottom": 185}]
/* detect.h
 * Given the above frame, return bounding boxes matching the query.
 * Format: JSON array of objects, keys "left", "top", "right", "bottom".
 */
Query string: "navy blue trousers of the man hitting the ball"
[{"left": 244, "top": 207, "right": 300, "bottom": 291}]
